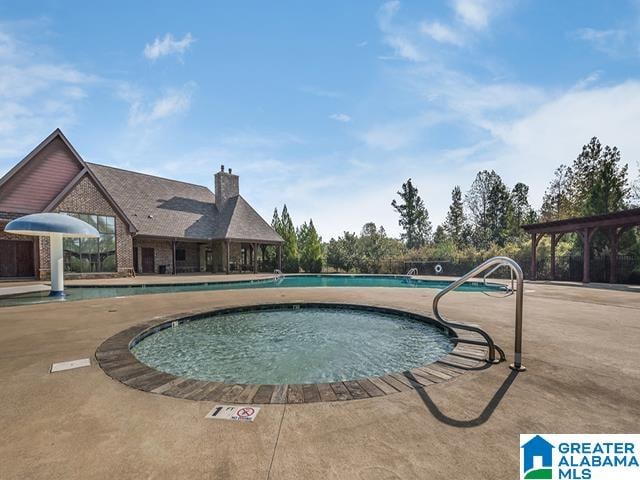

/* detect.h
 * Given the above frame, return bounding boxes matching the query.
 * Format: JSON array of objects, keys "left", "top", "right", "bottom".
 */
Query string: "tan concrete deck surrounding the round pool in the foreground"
[{"left": 0, "top": 284, "right": 640, "bottom": 480}]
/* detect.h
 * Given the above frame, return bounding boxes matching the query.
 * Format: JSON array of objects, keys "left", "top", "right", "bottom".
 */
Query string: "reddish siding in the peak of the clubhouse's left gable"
[{"left": 0, "top": 138, "right": 82, "bottom": 213}]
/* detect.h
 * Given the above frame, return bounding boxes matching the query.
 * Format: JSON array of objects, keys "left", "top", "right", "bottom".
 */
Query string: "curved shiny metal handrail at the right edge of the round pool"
[{"left": 433, "top": 257, "right": 526, "bottom": 371}]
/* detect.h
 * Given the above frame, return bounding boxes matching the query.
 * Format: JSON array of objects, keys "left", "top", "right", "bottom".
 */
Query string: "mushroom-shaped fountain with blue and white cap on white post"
[{"left": 4, "top": 213, "right": 100, "bottom": 297}]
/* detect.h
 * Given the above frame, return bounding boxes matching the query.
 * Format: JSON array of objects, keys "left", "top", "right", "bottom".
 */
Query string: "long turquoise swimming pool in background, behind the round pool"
[{"left": 0, "top": 274, "right": 505, "bottom": 306}]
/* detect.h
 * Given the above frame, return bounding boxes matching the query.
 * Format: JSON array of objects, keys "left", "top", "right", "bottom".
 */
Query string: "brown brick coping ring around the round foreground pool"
[{"left": 95, "top": 302, "right": 489, "bottom": 404}]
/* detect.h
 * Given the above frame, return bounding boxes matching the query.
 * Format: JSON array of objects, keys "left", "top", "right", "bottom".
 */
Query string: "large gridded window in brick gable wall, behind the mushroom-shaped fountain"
[{"left": 64, "top": 213, "right": 116, "bottom": 273}]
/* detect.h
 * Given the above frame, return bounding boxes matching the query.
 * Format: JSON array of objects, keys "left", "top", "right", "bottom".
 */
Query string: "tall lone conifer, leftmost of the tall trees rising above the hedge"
[{"left": 391, "top": 179, "right": 431, "bottom": 248}]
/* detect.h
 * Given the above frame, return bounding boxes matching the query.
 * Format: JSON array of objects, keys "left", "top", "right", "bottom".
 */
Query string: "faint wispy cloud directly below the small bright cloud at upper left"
[{"left": 121, "top": 83, "right": 194, "bottom": 125}]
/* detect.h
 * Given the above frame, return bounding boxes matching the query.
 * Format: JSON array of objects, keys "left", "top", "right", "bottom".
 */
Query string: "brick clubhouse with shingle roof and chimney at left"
[{"left": 0, "top": 129, "right": 283, "bottom": 280}]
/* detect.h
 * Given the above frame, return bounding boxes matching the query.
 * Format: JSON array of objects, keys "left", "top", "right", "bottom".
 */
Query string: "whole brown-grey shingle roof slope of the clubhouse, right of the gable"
[{"left": 87, "top": 162, "right": 282, "bottom": 242}]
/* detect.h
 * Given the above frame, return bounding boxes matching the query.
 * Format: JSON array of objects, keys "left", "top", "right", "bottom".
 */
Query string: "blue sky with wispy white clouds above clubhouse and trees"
[{"left": 0, "top": 0, "right": 640, "bottom": 239}]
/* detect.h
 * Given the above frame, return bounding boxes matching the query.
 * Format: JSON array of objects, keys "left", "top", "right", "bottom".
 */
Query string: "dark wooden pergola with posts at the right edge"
[{"left": 522, "top": 208, "right": 640, "bottom": 283}]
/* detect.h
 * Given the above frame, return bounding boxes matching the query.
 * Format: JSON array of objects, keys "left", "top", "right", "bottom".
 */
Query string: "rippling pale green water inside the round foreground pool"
[{"left": 131, "top": 306, "right": 454, "bottom": 384}]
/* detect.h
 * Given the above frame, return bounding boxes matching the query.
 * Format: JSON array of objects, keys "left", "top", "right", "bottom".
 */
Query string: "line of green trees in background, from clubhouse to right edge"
[{"left": 272, "top": 137, "right": 640, "bottom": 273}]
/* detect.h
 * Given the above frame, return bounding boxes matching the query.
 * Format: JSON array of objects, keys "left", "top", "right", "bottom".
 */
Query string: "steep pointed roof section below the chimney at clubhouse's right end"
[{"left": 214, "top": 195, "right": 284, "bottom": 243}]
